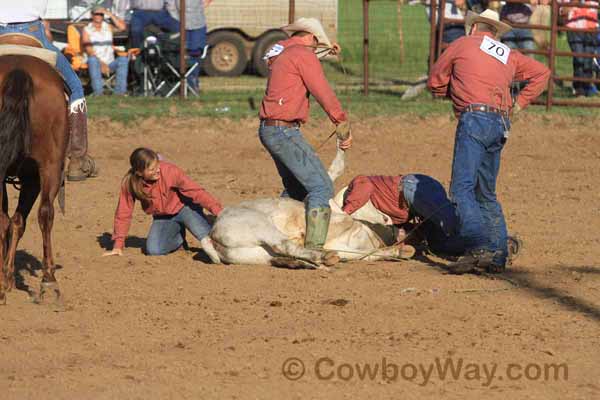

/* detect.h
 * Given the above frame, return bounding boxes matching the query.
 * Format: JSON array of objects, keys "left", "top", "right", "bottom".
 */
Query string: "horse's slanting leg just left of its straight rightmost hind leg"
[{"left": 6, "top": 176, "right": 40, "bottom": 290}]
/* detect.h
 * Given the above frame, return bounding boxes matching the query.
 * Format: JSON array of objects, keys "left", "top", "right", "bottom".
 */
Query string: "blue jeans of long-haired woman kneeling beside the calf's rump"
[{"left": 146, "top": 204, "right": 211, "bottom": 256}]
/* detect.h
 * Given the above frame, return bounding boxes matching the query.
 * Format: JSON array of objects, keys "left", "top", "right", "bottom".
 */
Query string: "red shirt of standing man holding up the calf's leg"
[{"left": 260, "top": 37, "right": 346, "bottom": 124}]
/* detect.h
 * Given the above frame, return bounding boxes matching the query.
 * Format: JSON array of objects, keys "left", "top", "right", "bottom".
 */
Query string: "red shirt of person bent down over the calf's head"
[{"left": 342, "top": 175, "right": 408, "bottom": 225}]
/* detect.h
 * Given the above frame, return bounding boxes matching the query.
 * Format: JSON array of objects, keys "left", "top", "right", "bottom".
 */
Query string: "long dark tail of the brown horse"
[{"left": 0, "top": 69, "right": 33, "bottom": 180}]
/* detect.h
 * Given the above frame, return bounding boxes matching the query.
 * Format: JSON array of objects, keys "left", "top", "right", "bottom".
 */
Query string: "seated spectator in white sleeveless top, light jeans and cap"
[{"left": 82, "top": 6, "right": 129, "bottom": 95}]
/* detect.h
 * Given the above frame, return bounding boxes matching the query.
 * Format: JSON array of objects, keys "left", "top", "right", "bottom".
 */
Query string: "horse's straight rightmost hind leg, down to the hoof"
[{"left": 38, "top": 163, "right": 62, "bottom": 301}]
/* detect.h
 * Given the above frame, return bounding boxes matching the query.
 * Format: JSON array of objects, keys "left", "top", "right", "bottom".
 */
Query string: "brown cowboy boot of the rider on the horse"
[{"left": 67, "top": 99, "right": 98, "bottom": 181}]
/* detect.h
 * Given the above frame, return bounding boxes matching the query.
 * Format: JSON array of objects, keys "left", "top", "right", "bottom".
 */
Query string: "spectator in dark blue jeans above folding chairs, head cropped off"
[{"left": 130, "top": 0, "right": 179, "bottom": 48}]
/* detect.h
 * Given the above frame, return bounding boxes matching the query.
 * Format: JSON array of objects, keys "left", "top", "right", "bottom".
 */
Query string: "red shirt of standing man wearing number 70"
[{"left": 427, "top": 32, "right": 550, "bottom": 114}]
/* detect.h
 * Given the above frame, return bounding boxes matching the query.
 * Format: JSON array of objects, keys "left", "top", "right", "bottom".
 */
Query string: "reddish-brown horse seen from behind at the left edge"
[{"left": 0, "top": 47, "right": 69, "bottom": 304}]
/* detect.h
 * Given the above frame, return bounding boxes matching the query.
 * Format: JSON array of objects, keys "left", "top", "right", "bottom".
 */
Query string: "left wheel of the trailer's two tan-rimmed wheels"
[{"left": 204, "top": 31, "right": 248, "bottom": 76}]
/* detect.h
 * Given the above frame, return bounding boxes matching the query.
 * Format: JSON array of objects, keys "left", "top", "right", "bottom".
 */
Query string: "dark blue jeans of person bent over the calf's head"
[{"left": 402, "top": 174, "right": 465, "bottom": 256}]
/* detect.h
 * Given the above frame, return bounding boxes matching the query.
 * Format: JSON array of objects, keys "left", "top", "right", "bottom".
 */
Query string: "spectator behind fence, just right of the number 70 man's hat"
[{"left": 500, "top": 0, "right": 537, "bottom": 52}]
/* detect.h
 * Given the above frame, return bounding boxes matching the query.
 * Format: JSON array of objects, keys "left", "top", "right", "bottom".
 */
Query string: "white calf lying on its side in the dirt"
[{"left": 203, "top": 142, "right": 413, "bottom": 267}]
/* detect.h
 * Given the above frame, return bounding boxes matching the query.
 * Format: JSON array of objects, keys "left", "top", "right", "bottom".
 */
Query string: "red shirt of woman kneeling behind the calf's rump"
[{"left": 112, "top": 161, "right": 223, "bottom": 249}]
